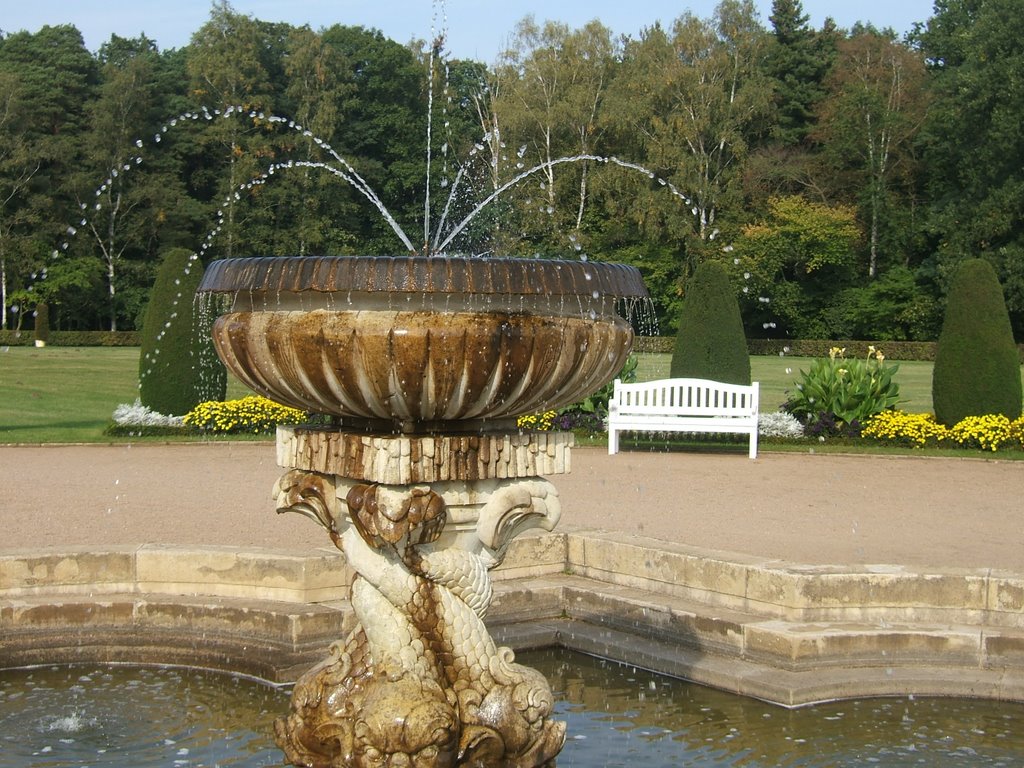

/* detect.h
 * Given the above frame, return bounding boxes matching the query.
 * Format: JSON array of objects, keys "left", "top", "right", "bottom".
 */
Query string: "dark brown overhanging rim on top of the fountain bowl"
[{"left": 193, "top": 256, "right": 648, "bottom": 298}]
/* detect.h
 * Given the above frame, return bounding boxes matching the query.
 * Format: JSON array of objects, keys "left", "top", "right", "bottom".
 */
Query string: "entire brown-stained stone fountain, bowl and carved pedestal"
[{"left": 200, "top": 256, "right": 647, "bottom": 768}]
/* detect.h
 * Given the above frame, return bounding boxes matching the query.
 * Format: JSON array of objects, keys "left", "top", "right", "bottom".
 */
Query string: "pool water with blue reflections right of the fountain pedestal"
[{"left": 518, "top": 649, "right": 1024, "bottom": 768}]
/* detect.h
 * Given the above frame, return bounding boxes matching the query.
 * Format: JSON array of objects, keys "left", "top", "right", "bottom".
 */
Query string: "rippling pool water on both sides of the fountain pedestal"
[{"left": 0, "top": 649, "right": 1024, "bottom": 768}]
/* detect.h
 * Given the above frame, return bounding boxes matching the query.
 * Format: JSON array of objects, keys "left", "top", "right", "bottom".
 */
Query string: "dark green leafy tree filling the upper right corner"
[{"left": 919, "top": 0, "right": 1024, "bottom": 336}]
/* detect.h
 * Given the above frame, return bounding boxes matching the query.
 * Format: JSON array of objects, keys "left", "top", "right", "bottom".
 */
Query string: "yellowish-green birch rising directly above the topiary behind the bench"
[{"left": 613, "top": 0, "right": 770, "bottom": 266}]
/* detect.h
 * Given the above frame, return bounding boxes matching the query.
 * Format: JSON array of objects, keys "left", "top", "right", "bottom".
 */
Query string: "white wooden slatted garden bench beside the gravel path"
[{"left": 608, "top": 379, "right": 758, "bottom": 459}]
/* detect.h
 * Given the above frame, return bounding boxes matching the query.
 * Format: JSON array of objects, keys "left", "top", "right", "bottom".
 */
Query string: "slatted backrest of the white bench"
[{"left": 609, "top": 379, "right": 759, "bottom": 418}]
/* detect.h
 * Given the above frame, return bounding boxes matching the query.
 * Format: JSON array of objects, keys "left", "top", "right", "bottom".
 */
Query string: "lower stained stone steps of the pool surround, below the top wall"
[{"left": 6, "top": 575, "right": 1024, "bottom": 706}]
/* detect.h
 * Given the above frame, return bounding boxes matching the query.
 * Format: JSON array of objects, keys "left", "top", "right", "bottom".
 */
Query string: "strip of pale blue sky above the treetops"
[{"left": 0, "top": 0, "right": 933, "bottom": 63}]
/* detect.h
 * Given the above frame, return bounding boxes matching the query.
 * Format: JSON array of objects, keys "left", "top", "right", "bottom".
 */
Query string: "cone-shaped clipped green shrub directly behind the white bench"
[{"left": 671, "top": 261, "right": 751, "bottom": 384}]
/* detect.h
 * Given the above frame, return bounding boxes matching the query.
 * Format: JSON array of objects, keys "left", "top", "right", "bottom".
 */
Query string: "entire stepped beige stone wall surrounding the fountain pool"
[{"left": 0, "top": 529, "right": 1024, "bottom": 707}]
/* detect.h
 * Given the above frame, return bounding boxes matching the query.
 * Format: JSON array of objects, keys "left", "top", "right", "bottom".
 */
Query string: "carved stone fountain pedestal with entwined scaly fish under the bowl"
[{"left": 275, "top": 427, "right": 572, "bottom": 768}]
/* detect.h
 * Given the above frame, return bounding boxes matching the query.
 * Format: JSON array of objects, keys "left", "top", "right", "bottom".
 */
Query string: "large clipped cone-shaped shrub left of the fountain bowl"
[{"left": 138, "top": 248, "right": 227, "bottom": 416}]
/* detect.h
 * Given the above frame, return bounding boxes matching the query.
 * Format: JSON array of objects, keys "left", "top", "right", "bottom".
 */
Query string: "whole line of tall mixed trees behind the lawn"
[{"left": 0, "top": 0, "right": 1024, "bottom": 340}]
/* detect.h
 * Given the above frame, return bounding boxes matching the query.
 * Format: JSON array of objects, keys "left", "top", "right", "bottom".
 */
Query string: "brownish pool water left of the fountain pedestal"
[{"left": 0, "top": 666, "right": 289, "bottom": 768}]
